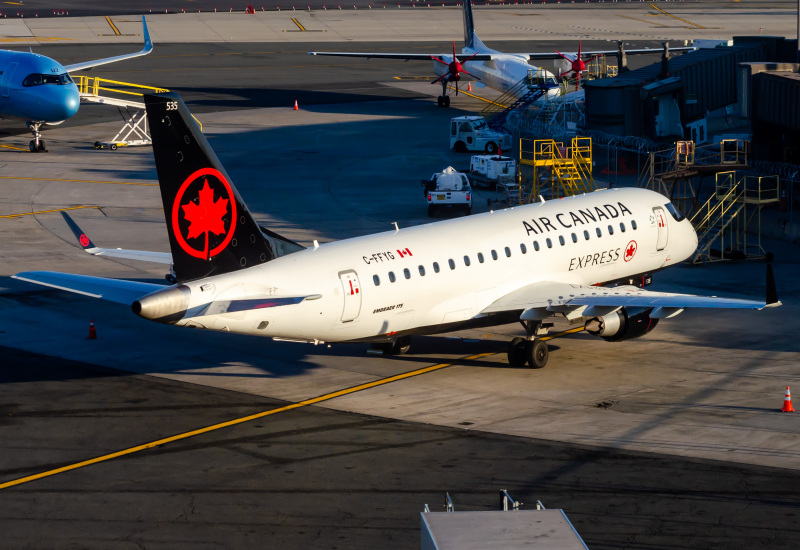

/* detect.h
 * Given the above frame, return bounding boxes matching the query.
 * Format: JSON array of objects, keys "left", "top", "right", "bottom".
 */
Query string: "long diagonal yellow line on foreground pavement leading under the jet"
[{"left": 0, "top": 327, "right": 583, "bottom": 490}]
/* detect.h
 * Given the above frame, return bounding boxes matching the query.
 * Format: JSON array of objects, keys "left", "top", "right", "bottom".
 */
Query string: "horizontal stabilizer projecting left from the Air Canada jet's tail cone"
[{"left": 11, "top": 271, "right": 164, "bottom": 305}]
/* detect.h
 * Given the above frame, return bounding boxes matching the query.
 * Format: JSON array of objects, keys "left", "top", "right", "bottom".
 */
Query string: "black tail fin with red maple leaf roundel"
[{"left": 144, "top": 92, "right": 276, "bottom": 282}]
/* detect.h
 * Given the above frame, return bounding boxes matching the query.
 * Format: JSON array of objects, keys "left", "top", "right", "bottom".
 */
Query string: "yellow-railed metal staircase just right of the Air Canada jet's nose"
[{"left": 690, "top": 171, "right": 780, "bottom": 264}]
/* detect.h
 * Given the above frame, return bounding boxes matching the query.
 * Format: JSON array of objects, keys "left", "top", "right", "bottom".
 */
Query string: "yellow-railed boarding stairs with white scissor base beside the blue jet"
[{"left": 76, "top": 75, "right": 203, "bottom": 151}]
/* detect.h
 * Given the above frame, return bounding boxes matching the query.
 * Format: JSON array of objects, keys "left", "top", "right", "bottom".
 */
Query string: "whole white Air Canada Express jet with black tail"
[{"left": 15, "top": 93, "right": 780, "bottom": 368}]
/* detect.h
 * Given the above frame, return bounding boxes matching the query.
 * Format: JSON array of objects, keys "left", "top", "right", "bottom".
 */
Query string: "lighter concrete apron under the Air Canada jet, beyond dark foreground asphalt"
[{"left": 0, "top": 99, "right": 800, "bottom": 474}]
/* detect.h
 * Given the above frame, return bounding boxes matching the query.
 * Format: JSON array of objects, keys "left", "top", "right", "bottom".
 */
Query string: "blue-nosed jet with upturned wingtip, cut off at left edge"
[{"left": 0, "top": 17, "right": 153, "bottom": 153}]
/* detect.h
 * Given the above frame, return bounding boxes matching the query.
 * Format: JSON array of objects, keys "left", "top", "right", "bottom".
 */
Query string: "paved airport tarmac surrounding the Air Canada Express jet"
[{"left": 0, "top": 5, "right": 800, "bottom": 549}]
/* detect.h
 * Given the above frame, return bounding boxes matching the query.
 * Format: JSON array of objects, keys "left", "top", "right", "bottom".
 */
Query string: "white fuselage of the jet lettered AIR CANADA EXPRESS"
[{"left": 170, "top": 189, "right": 697, "bottom": 342}]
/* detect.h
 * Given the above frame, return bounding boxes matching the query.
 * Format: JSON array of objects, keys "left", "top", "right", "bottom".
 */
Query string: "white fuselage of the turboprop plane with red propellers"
[{"left": 433, "top": 44, "right": 559, "bottom": 97}]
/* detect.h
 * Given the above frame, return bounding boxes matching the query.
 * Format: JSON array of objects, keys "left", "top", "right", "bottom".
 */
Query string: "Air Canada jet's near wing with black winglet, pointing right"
[{"left": 481, "top": 274, "right": 781, "bottom": 320}]
